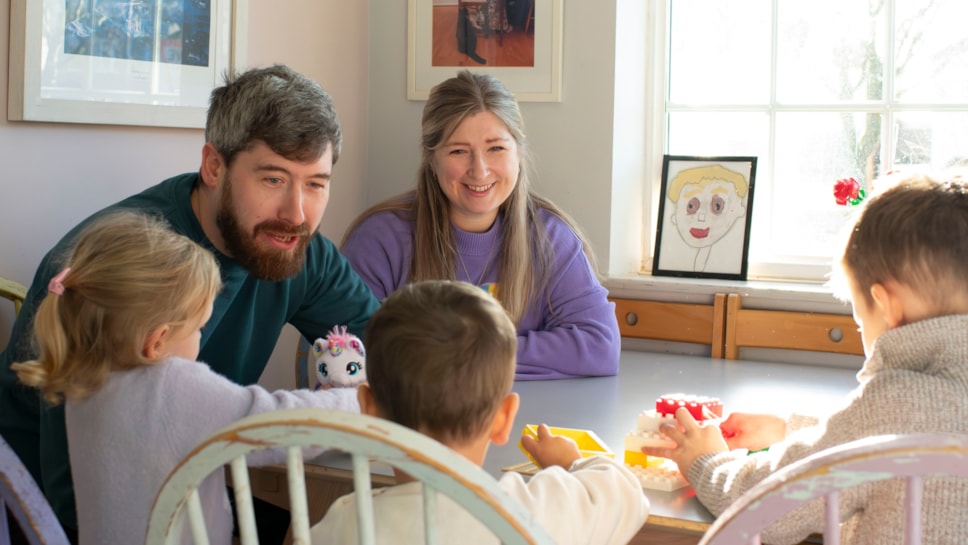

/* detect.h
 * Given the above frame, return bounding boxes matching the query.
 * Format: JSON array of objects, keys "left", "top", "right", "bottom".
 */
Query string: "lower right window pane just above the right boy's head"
[{"left": 894, "top": 112, "right": 968, "bottom": 169}]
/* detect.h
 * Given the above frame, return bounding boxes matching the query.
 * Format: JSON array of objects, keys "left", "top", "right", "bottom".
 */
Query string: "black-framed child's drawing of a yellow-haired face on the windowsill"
[{"left": 652, "top": 155, "right": 756, "bottom": 280}]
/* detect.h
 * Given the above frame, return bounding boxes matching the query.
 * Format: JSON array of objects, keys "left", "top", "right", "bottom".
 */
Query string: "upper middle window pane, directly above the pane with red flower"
[{"left": 776, "top": 0, "right": 886, "bottom": 104}]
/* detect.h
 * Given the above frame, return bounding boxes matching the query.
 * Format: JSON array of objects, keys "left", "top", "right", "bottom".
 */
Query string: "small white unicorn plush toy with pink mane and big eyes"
[{"left": 313, "top": 326, "right": 366, "bottom": 389}]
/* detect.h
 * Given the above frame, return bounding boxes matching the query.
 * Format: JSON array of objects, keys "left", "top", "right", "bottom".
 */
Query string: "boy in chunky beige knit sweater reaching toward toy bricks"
[{"left": 643, "top": 172, "right": 968, "bottom": 545}]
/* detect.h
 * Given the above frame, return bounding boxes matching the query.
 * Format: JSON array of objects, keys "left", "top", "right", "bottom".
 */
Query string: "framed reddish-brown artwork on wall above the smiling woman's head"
[{"left": 407, "top": 0, "right": 564, "bottom": 102}]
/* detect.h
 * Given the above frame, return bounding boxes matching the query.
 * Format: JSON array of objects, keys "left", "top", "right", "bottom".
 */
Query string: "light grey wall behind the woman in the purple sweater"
[{"left": 366, "top": 0, "right": 628, "bottom": 269}]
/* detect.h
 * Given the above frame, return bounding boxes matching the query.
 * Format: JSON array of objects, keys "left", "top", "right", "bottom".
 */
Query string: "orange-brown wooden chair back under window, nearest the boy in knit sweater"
[{"left": 724, "top": 293, "right": 864, "bottom": 360}]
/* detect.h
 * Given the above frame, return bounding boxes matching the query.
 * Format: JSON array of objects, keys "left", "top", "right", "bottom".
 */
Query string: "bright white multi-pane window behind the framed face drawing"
[{"left": 651, "top": 0, "right": 968, "bottom": 280}]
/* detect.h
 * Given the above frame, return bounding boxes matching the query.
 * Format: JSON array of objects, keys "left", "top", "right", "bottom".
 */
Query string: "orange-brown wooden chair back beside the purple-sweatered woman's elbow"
[{"left": 610, "top": 293, "right": 726, "bottom": 358}]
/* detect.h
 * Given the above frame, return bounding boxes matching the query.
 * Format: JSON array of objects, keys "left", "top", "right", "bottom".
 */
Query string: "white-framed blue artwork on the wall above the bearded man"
[{"left": 7, "top": 0, "right": 248, "bottom": 128}]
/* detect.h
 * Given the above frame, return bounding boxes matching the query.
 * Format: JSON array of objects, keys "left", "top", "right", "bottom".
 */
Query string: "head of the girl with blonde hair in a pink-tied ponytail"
[{"left": 12, "top": 213, "right": 222, "bottom": 405}]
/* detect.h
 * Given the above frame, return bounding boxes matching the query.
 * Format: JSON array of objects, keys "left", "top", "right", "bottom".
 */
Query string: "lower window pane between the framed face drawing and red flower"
[{"left": 764, "top": 112, "right": 881, "bottom": 257}]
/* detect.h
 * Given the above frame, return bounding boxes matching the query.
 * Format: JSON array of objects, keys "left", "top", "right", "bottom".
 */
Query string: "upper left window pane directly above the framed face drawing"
[{"left": 669, "top": 0, "right": 770, "bottom": 104}]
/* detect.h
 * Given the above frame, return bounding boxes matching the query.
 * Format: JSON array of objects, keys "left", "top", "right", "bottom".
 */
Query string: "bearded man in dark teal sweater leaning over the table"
[{"left": 0, "top": 65, "right": 379, "bottom": 542}]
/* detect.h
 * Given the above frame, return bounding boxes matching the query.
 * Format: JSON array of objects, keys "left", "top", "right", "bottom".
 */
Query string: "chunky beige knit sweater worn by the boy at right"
[{"left": 687, "top": 315, "right": 968, "bottom": 545}]
